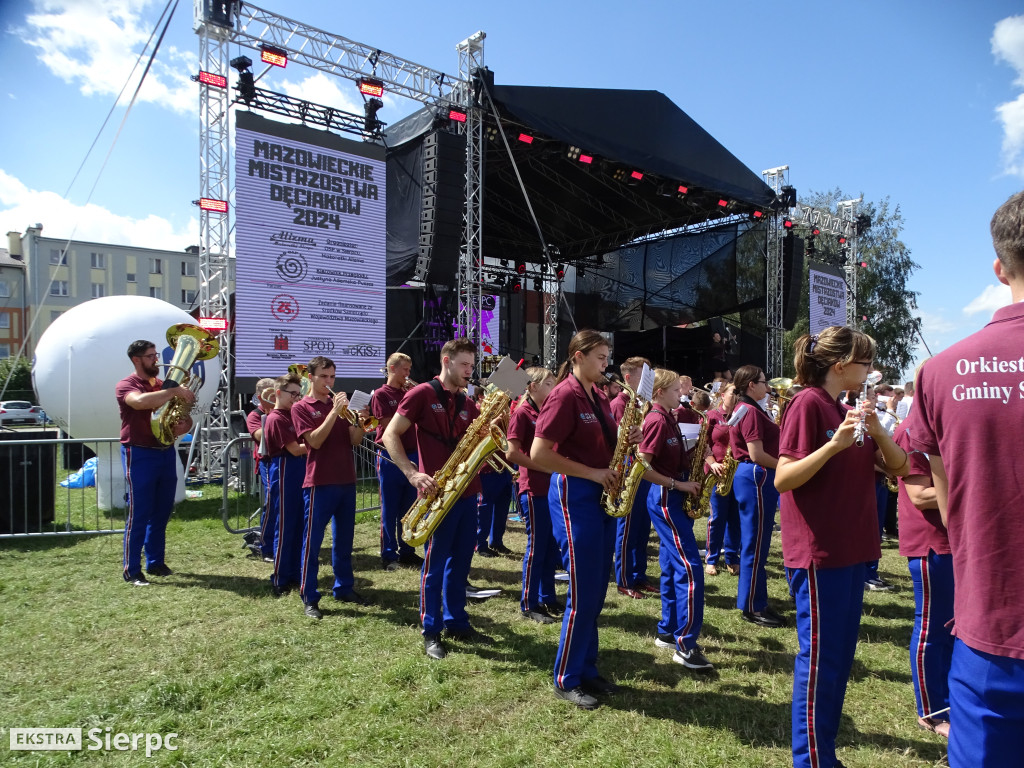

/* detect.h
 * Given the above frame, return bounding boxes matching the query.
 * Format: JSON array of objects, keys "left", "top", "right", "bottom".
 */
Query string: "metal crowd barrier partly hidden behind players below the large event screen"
[{"left": 220, "top": 434, "right": 381, "bottom": 535}]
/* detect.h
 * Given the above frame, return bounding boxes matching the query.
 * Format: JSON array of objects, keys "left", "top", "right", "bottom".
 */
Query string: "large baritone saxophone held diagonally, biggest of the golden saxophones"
[{"left": 401, "top": 384, "right": 513, "bottom": 547}]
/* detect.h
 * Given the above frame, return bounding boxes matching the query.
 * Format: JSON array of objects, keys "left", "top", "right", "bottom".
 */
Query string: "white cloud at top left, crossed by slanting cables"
[{"left": 23, "top": 0, "right": 199, "bottom": 114}]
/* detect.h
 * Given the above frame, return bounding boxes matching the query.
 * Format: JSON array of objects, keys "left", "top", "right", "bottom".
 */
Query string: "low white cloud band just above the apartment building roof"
[{"left": 0, "top": 169, "right": 199, "bottom": 251}]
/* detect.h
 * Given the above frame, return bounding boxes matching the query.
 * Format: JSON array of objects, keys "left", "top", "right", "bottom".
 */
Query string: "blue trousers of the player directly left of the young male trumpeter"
[{"left": 263, "top": 452, "right": 306, "bottom": 589}]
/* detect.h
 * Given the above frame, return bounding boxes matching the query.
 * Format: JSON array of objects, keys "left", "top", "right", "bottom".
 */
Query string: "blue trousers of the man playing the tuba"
[{"left": 121, "top": 444, "right": 178, "bottom": 582}]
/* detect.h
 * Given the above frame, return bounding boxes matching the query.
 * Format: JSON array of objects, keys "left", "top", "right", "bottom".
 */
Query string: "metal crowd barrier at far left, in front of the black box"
[{"left": 0, "top": 429, "right": 125, "bottom": 539}]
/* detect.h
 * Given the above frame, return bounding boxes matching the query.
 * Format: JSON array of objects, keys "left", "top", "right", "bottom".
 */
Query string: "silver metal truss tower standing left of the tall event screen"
[{"left": 193, "top": 0, "right": 233, "bottom": 479}]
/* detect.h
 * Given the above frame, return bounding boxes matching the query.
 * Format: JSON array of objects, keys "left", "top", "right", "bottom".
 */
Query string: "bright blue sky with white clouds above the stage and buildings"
[{"left": 0, "top": 0, "right": 1024, "bottom": 374}]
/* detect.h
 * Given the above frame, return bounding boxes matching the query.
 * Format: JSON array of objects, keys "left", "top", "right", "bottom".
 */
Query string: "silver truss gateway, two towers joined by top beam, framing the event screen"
[{"left": 193, "top": 0, "right": 485, "bottom": 477}]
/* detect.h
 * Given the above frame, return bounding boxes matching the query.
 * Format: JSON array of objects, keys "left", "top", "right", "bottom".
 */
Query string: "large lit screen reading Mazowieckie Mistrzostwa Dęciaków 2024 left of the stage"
[{"left": 234, "top": 112, "right": 387, "bottom": 378}]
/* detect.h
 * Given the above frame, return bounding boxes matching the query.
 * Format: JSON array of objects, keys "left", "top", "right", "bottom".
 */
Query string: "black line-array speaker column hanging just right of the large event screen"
[{"left": 416, "top": 131, "right": 466, "bottom": 286}]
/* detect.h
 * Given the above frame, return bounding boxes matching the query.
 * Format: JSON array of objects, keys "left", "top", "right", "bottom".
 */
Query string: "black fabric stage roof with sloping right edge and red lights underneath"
[{"left": 387, "top": 85, "right": 775, "bottom": 272}]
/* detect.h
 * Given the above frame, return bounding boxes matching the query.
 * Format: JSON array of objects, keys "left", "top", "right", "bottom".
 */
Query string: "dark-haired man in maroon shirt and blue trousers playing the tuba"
[{"left": 115, "top": 339, "right": 196, "bottom": 587}]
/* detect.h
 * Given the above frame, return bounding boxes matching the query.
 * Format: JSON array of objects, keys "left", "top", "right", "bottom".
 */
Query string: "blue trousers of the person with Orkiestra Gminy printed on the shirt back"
[{"left": 949, "top": 639, "right": 1024, "bottom": 768}]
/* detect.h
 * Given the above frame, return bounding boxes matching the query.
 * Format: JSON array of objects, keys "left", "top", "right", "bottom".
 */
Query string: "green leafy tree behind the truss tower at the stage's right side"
[{"left": 783, "top": 188, "right": 921, "bottom": 381}]
